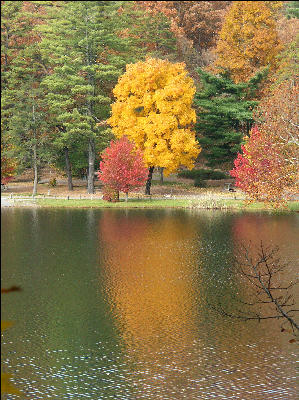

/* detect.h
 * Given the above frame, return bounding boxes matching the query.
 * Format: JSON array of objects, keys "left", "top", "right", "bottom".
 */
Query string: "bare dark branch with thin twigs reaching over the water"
[{"left": 213, "top": 242, "right": 299, "bottom": 335}]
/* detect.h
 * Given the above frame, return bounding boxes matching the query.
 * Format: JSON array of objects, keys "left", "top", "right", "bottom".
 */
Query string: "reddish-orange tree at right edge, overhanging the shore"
[{"left": 231, "top": 79, "right": 299, "bottom": 206}]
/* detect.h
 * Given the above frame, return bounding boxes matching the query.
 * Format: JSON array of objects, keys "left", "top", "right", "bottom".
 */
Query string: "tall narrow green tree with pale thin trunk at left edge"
[{"left": 2, "top": 1, "right": 48, "bottom": 194}]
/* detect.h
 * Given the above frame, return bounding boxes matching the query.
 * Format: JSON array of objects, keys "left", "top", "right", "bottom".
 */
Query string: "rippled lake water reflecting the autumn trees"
[{"left": 1, "top": 209, "right": 299, "bottom": 400}]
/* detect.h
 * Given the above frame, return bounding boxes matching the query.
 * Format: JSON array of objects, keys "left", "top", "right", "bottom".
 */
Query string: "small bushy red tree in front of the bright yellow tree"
[{"left": 98, "top": 136, "right": 148, "bottom": 201}]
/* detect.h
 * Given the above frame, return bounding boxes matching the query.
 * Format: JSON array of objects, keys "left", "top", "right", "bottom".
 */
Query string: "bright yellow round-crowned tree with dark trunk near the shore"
[{"left": 108, "top": 58, "right": 200, "bottom": 194}]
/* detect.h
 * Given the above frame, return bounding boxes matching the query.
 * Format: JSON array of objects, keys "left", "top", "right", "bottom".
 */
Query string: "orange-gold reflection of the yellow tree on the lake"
[{"left": 99, "top": 212, "right": 200, "bottom": 398}]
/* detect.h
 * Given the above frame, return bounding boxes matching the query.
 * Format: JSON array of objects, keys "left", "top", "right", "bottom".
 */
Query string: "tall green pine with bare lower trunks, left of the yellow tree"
[{"left": 41, "top": 1, "right": 133, "bottom": 193}]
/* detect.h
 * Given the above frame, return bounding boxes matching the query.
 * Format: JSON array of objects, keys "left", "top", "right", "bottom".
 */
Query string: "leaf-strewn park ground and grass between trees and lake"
[{"left": 1, "top": 169, "right": 299, "bottom": 212}]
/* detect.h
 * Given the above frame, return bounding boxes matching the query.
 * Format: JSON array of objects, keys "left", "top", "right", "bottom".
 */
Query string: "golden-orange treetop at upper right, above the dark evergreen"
[{"left": 214, "top": 1, "right": 283, "bottom": 83}]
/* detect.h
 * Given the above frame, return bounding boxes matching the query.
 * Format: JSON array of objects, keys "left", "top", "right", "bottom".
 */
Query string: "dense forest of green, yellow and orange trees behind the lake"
[{"left": 1, "top": 1, "right": 299, "bottom": 202}]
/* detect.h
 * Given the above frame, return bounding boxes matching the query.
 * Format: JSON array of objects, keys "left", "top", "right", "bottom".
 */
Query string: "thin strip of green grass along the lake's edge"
[{"left": 32, "top": 199, "right": 299, "bottom": 212}]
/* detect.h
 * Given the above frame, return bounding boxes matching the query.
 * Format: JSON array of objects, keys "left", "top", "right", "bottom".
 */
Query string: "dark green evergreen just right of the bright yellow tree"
[{"left": 194, "top": 69, "right": 267, "bottom": 167}]
